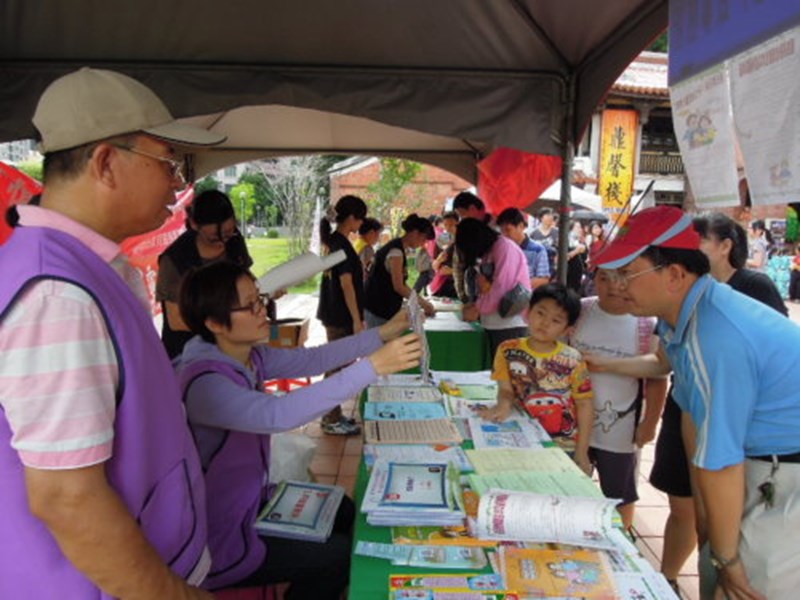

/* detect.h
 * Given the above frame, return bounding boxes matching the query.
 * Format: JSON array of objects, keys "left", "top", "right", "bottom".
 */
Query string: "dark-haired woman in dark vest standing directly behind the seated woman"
[{"left": 156, "top": 190, "right": 253, "bottom": 358}]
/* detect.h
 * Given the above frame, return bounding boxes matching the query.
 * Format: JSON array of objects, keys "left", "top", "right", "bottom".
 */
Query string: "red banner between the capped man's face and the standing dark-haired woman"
[{"left": 122, "top": 187, "right": 194, "bottom": 315}]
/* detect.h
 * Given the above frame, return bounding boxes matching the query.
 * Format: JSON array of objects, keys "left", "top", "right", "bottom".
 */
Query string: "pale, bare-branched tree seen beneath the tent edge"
[{"left": 254, "top": 156, "right": 326, "bottom": 257}]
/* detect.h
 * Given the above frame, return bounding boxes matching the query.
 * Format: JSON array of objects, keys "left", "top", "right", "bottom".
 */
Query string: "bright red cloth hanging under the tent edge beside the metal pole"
[{"left": 478, "top": 148, "right": 562, "bottom": 215}]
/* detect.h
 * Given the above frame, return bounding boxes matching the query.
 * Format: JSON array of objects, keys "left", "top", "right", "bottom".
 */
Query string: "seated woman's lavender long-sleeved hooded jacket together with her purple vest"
[{"left": 176, "top": 329, "right": 382, "bottom": 589}]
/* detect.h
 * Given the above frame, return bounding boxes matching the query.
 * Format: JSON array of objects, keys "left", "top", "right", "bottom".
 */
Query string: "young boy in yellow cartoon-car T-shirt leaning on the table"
[{"left": 482, "top": 283, "right": 594, "bottom": 474}]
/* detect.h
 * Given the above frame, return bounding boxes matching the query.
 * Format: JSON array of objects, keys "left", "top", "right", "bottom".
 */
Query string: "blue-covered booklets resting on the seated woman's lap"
[{"left": 255, "top": 481, "right": 344, "bottom": 542}]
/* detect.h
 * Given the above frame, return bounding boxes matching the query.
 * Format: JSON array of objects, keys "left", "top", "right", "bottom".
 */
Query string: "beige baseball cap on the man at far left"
[{"left": 33, "top": 67, "right": 226, "bottom": 154}]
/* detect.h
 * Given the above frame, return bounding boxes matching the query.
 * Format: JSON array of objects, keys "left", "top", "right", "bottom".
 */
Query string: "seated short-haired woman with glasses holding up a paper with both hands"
[{"left": 176, "top": 262, "right": 421, "bottom": 600}]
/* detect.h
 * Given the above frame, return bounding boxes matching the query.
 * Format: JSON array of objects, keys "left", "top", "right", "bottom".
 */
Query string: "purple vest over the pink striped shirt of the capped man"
[{"left": 0, "top": 227, "right": 206, "bottom": 600}]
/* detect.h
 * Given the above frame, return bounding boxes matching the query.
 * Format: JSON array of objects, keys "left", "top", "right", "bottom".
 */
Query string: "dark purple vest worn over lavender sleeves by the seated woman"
[{"left": 178, "top": 352, "right": 270, "bottom": 590}]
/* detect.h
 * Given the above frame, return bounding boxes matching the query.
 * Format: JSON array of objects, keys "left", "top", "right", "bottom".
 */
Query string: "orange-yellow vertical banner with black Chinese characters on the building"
[{"left": 597, "top": 109, "right": 639, "bottom": 219}]
